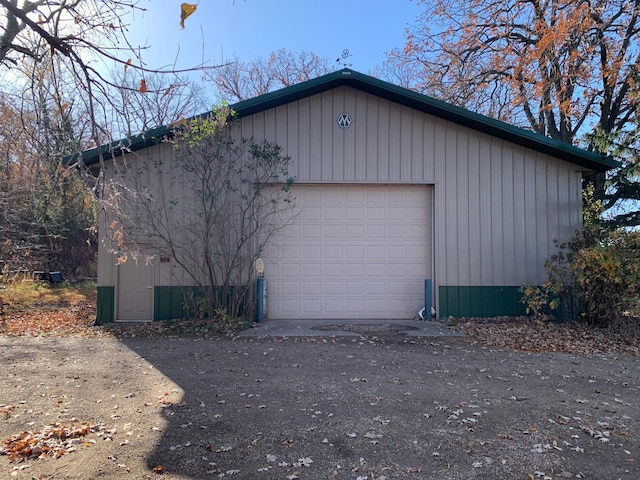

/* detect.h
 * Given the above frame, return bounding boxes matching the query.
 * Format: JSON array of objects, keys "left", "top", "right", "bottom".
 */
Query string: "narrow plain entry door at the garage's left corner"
[{"left": 116, "top": 255, "right": 153, "bottom": 322}]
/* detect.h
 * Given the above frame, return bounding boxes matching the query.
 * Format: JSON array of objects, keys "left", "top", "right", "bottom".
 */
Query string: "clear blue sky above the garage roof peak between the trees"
[{"left": 129, "top": 0, "right": 424, "bottom": 73}]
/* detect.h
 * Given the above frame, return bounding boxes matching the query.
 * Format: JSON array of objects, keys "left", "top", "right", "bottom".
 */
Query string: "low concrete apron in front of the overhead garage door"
[{"left": 238, "top": 319, "right": 463, "bottom": 337}]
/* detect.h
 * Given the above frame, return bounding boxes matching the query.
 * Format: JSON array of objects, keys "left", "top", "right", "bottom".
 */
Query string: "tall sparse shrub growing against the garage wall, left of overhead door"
[{"left": 104, "top": 107, "right": 293, "bottom": 318}]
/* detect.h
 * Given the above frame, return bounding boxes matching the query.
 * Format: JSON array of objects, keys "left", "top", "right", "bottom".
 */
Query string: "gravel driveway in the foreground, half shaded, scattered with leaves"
[{"left": 0, "top": 330, "right": 640, "bottom": 480}]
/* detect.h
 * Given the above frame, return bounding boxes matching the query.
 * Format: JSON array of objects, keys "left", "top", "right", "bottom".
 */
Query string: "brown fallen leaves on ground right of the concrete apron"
[{"left": 454, "top": 318, "right": 640, "bottom": 356}]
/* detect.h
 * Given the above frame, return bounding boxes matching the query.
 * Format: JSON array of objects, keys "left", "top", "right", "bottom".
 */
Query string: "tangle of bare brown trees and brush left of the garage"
[{"left": 0, "top": 71, "right": 97, "bottom": 275}]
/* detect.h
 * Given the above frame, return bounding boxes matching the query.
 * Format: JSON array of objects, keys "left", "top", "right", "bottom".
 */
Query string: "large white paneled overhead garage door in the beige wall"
[{"left": 265, "top": 185, "right": 432, "bottom": 319}]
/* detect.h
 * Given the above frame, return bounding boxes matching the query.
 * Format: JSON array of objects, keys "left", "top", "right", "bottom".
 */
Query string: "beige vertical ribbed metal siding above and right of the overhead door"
[{"left": 236, "top": 87, "right": 582, "bottom": 300}]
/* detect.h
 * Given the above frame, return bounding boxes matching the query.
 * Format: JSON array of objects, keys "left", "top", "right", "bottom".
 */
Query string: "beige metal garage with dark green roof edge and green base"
[{"left": 90, "top": 69, "right": 618, "bottom": 323}]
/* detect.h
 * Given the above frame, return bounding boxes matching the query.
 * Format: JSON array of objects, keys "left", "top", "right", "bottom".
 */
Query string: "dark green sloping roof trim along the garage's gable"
[{"left": 74, "top": 68, "right": 622, "bottom": 172}]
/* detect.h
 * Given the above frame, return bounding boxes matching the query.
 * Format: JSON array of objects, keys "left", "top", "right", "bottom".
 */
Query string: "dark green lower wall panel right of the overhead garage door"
[{"left": 438, "top": 286, "right": 526, "bottom": 318}]
